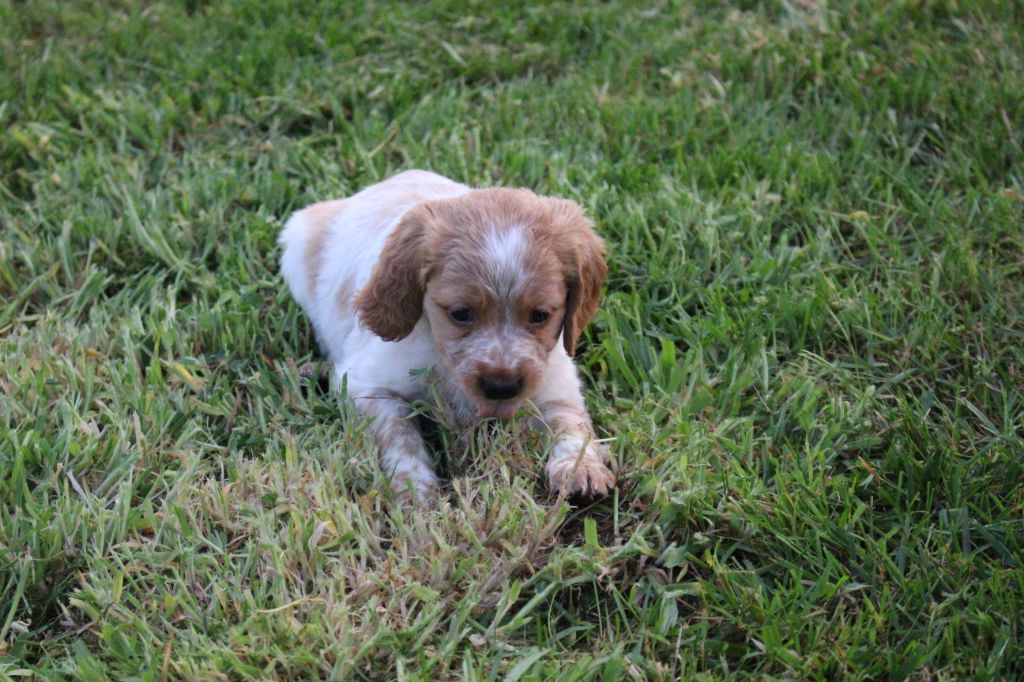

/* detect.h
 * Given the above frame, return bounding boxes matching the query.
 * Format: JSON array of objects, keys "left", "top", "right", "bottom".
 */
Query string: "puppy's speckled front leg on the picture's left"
[{"left": 352, "top": 389, "right": 437, "bottom": 499}]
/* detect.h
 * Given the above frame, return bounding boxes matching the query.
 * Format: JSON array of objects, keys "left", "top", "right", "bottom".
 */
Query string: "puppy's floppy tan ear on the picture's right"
[{"left": 555, "top": 201, "right": 608, "bottom": 357}]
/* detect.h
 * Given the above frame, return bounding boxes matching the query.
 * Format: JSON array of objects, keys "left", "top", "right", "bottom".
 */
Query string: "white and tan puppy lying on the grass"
[{"left": 280, "top": 170, "right": 615, "bottom": 497}]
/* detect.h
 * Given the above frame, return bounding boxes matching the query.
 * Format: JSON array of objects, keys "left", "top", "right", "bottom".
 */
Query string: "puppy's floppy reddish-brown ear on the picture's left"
[{"left": 355, "top": 204, "right": 433, "bottom": 341}]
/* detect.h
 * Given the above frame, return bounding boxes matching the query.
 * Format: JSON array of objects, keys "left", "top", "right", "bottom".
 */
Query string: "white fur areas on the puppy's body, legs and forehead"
[{"left": 279, "top": 171, "right": 613, "bottom": 495}]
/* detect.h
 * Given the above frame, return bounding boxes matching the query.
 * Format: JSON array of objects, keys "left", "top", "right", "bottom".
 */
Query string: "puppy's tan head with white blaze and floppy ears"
[{"left": 355, "top": 189, "right": 607, "bottom": 418}]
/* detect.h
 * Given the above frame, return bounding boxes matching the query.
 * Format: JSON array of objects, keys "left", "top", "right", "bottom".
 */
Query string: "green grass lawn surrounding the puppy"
[{"left": 0, "top": 0, "right": 1024, "bottom": 680}]
